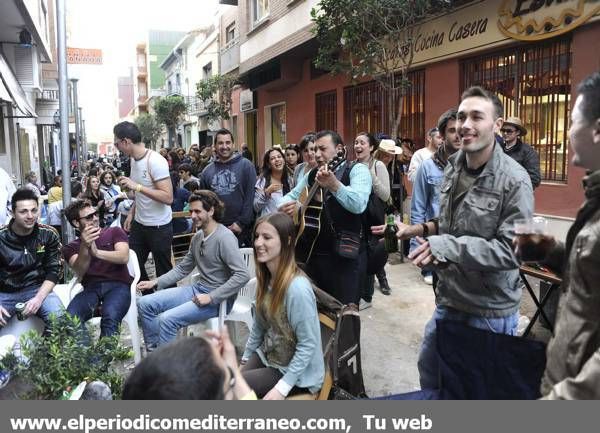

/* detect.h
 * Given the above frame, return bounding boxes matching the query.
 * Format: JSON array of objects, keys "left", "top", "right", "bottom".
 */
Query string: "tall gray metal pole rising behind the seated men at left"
[{"left": 56, "top": 0, "right": 73, "bottom": 245}]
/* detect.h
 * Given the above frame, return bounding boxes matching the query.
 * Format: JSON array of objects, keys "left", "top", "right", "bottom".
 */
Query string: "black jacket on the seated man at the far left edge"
[{"left": 0, "top": 220, "right": 62, "bottom": 293}]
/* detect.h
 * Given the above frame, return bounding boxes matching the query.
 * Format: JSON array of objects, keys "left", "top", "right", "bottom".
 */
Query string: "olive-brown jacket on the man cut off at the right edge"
[{"left": 541, "top": 171, "right": 600, "bottom": 400}]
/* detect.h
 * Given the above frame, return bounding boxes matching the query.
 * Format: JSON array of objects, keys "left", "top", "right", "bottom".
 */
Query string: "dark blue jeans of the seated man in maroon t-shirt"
[{"left": 67, "top": 281, "right": 131, "bottom": 337}]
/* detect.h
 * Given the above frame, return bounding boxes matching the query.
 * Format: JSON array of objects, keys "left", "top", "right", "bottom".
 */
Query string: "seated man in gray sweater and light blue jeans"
[{"left": 138, "top": 191, "right": 250, "bottom": 351}]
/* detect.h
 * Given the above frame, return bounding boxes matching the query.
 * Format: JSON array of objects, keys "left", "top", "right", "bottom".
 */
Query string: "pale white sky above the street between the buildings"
[{"left": 66, "top": 0, "right": 218, "bottom": 143}]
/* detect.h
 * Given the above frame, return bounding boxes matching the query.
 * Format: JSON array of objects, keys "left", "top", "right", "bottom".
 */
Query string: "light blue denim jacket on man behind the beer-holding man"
[{"left": 410, "top": 158, "right": 444, "bottom": 250}]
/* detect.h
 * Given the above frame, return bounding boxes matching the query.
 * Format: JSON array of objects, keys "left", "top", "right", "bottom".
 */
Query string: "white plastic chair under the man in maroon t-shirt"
[{"left": 54, "top": 249, "right": 142, "bottom": 364}]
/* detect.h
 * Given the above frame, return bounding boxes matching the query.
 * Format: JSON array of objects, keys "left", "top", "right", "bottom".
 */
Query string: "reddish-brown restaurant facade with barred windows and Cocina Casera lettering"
[{"left": 221, "top": 0, "right": 600, "bottom": 218}]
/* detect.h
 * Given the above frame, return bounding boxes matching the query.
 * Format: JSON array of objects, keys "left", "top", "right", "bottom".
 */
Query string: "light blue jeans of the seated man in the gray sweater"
[{"left": 138, "top": 284, "right": 234, "bottom": 350}]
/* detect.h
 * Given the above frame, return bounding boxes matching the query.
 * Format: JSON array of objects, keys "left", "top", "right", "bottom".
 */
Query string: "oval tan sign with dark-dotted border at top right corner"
[{"left": 498, "top": 0, "right": 600, "bottom": 41}]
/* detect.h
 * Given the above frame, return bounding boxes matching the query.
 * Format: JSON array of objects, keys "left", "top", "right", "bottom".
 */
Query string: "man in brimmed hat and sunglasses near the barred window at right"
[{"left": 500, "top": 117, "right": 541, "bottom": 189}]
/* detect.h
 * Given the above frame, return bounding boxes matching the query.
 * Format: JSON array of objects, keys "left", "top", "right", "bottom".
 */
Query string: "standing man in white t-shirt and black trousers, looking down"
[{"left": 113, "top": 122, "right": 173, "bottom": 280}]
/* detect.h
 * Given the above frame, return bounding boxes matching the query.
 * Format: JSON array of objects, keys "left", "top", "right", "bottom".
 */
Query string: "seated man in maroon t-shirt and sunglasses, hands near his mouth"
[{"left": 63, "top": 200, "right": 132, "bottom": 337}]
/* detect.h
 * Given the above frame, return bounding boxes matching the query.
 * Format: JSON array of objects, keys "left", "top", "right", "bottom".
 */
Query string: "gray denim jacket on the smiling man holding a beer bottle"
[{"left": 428, "top": 144, "right": 534, "bottom": 317}]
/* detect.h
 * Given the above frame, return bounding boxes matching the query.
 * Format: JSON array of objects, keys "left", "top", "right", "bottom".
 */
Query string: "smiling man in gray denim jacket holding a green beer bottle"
[{"left": 373, "top": 87, "right": 533, "bottom": 389}]
